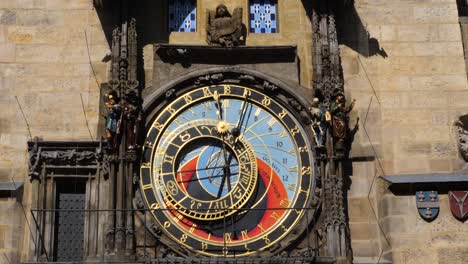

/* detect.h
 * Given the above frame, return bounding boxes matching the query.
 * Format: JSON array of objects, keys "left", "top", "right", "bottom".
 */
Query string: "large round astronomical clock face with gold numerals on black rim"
[{"left": 140, "top": 85, "right": 315, "bottom": 257}]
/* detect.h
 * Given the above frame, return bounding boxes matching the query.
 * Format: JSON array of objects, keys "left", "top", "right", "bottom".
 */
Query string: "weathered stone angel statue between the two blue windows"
[{"left": 207, "top": 4, "right": 246, "bottom": 47}]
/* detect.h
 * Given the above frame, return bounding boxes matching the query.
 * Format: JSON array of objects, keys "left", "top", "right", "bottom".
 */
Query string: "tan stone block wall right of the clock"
[{"left": 340, "top": 0, "right": 468, "bottom": 263}]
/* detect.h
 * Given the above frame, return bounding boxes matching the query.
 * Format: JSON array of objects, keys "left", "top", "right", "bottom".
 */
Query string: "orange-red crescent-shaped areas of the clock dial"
[{"left": 171, "top": 157, "right": 289, "bottom": 242}]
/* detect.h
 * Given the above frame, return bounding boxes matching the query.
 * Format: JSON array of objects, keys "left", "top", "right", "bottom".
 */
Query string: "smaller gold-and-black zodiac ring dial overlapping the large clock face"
[{"left": 153, "top": 119, "right": 257, "bottom": 220}]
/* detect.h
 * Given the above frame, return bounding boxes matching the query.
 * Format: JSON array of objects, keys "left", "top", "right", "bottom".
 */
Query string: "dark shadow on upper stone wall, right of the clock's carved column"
[{"left": 337, "top": 0, "right": 388, "bottom": 58}]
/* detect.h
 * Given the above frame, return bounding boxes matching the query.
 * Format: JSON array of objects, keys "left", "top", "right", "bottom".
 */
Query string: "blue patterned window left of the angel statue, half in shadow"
[{"left": 168, "top": 0, "right": 197, "bottom": 32}]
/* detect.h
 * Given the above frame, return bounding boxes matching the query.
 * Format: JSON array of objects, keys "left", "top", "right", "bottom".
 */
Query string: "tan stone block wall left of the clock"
[{"left": 0, "top": 0, "right": 109, "bottom": 263}]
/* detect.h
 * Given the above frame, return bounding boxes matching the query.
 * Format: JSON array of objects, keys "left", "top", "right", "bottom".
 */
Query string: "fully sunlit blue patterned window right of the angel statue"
[{"left": 249, "top": 0, "right": 278, "bottom": 33}]
